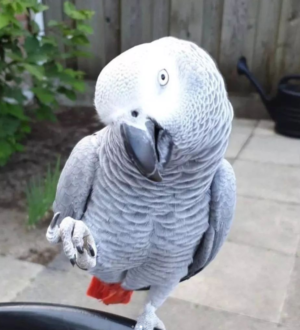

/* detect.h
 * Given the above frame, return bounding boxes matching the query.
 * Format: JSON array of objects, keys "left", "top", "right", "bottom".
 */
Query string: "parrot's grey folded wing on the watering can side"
[{"left": 182, "top": 160, "right": 236, "bottom": 280}]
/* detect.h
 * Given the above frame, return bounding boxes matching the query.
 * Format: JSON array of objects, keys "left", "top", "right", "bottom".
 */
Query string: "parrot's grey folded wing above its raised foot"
[{"left": 53, "top": 135, "right": 99, "bottom": 220}]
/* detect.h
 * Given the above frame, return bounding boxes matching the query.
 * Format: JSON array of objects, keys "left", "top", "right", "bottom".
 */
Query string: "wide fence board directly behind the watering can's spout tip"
[{"left": 219, "top": 0, "right": 258, "bottom": 92}]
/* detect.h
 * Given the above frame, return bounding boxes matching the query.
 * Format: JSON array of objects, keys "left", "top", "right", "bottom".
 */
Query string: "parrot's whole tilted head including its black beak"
[{"left": 95, "top": 37, "right": 233, "bottom": 181}]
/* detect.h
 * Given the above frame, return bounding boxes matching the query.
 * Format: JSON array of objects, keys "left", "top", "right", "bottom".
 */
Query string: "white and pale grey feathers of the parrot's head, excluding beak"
[{"left": 95, "top": 37, "right": 232, "bottom": 149}]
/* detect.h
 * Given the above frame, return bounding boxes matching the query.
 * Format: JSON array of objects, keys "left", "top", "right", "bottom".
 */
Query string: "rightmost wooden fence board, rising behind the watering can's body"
[{"left": 273, "top": 0, "right": 300, "bottom": 89}]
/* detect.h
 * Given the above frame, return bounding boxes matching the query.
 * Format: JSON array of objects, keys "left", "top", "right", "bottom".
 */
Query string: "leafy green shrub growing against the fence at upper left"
[{"left": 0, "top": 0, "right": 93, "bottom": 166}]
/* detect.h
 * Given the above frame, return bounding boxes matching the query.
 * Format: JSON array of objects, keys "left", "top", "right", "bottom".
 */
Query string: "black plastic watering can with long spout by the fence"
[{"left": 237, "top": 57, "right": 300, "bottom": 138}]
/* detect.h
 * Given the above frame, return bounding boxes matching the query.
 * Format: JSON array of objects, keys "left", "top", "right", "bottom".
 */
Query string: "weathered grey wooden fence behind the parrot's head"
[{"left": 44, "top": 0, "right": 300, "bottom": 92}]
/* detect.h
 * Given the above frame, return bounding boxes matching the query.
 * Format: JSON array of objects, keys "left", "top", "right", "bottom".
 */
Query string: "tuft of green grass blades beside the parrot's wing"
[{"left": 26, "top": 157, "right": 61, "bottom": 227}]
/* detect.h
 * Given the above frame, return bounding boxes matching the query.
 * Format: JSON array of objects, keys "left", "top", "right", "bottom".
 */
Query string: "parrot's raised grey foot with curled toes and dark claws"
[{"left": 46, "top": 213, "right": 97, "bottom": 270}]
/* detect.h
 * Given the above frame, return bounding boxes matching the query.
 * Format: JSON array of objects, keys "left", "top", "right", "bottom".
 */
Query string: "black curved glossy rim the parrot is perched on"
[{"left": 0, "top": 303, "right": 159, "bottom": 330}]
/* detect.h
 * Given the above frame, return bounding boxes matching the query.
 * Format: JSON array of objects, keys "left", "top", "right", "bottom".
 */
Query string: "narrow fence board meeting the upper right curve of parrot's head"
[{"left": 201, "top": 0, "right": 224, "bottom": 61}]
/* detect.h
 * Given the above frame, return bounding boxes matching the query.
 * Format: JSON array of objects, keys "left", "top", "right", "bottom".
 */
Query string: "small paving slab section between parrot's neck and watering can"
[{"left": 225, "top": 119, "right": 257, "bottom": 158}]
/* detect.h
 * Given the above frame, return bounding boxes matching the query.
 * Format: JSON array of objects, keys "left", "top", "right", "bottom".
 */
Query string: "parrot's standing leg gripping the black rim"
[{"left": 134, "top": 283, "right": 177, "bottom": 330}]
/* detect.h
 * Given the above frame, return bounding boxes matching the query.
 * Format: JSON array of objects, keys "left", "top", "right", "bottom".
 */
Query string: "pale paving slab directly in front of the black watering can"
[{"left": 239, "top": 135, "right": 300, "bottom": 166}]
